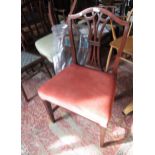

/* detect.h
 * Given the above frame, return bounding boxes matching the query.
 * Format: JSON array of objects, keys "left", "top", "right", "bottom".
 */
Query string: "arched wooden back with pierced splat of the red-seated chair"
[{"left": 68, "top": 7, "right": 128, "bottom": 74}]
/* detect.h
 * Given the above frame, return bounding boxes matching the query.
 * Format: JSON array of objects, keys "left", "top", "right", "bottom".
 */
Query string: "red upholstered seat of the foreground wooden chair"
[{"left": 38, "top": 64, "right": 115, "bottom": 127}]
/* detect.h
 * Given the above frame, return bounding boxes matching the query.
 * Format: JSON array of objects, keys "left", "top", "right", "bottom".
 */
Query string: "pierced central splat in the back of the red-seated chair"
[{"left": 84, "top": 12, "right": 110, "bottom": 69}]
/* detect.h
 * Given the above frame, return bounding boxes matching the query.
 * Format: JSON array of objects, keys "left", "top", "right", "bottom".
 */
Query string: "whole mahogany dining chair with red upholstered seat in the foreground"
[{"left": 38, "top": 7, "right": 129, "bottom": 146}]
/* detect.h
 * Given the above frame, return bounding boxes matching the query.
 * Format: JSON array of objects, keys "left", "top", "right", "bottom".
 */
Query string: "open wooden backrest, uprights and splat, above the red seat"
[{"left": 68, "top": 7, "right": 129, "bottom": 74}]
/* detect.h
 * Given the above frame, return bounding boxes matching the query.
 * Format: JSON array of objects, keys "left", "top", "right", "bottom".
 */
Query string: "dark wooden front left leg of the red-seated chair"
[{"left": 44, "top": 101, "right": 55, "bottom": 123}]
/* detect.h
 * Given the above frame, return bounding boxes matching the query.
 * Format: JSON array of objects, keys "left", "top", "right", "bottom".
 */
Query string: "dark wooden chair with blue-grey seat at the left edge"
[{"left": 21, "top": 0, "right": 52, "bottom": 101}]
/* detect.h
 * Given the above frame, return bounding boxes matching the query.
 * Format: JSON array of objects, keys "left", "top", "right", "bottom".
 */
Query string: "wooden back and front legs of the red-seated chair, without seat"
[{"left": 41, "top": 7, "right": 129, "bottom": 147}]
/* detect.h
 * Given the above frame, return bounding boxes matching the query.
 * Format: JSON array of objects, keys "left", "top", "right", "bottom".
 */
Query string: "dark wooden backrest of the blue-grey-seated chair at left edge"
[{"left": 21, "top": 0, "right": 51, "bottom": 51}]
